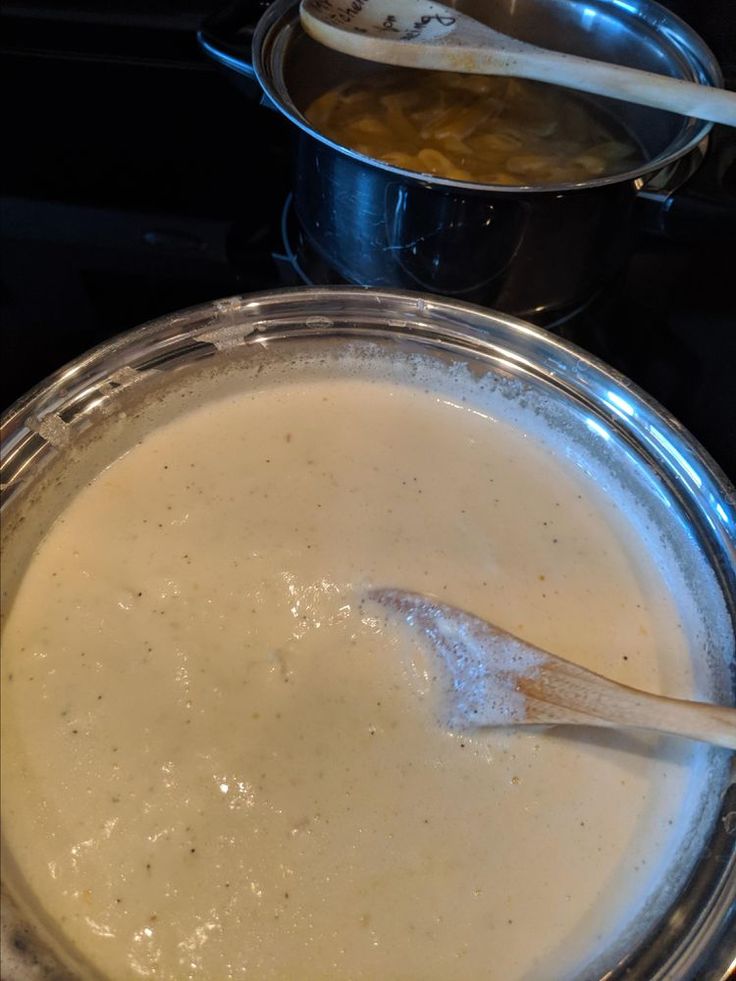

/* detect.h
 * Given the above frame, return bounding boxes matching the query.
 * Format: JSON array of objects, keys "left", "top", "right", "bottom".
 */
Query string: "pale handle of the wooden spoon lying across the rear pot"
[{"left": 504, "top": 49, "right": 736, "bottom": 126}]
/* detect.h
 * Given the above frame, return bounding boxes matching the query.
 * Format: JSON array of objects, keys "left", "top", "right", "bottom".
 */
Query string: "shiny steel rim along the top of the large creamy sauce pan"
[{"left": 0, "top": 285, "right": 736, "bottom": 536}]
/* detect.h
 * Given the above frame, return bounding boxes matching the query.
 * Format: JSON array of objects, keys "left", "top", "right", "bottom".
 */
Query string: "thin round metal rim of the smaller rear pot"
[{"left": 252, "top": 0, "right": 724, "bottom": 194}]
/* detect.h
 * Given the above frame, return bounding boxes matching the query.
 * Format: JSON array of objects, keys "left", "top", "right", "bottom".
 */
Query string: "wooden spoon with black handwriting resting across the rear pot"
[{"left": 300, "top": 0, "right": 736, "bottom": 126}]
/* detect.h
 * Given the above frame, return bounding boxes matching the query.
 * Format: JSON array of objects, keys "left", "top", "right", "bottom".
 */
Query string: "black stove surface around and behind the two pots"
[{"left": 0, "top": 0, "right": 736, "bottom": 480}]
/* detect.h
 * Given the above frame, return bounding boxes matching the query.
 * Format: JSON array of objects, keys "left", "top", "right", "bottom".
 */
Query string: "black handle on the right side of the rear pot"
[{"left": 638, "top": 127, "right": 736, "bottom": 245}]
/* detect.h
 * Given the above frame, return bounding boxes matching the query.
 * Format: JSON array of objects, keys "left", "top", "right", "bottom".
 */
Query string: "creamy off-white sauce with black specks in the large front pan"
[{"left": 2, "top": 354, "right": 724, "bottom": 981}]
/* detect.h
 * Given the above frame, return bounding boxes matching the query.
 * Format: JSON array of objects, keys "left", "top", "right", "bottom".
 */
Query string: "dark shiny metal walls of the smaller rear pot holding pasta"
[{"left": 200, "top": 0, "right": 722, "bottom": 324}]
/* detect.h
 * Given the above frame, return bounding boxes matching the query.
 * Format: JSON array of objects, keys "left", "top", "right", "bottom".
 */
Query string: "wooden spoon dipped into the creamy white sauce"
[{"left": 369, "top": 589, "right": 736, "bottom": 749}]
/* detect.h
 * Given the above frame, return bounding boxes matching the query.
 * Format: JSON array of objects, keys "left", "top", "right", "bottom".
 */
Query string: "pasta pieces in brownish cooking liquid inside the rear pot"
[{"left": 306, "top": 71, "right": 642, "bottom": 185}]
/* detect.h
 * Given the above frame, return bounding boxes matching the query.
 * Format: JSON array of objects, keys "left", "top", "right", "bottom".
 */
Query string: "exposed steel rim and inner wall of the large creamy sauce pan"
[{"left": 0, "top": 289, "right": 736, "bottom": 981}]
